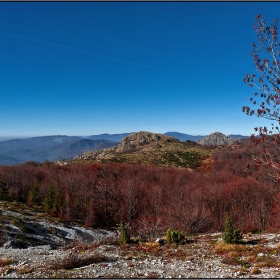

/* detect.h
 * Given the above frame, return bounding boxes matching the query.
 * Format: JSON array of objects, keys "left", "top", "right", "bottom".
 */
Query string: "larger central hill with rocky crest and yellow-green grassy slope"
[{"left": 70, "top": 131, "right": 211, "bottom": 169}]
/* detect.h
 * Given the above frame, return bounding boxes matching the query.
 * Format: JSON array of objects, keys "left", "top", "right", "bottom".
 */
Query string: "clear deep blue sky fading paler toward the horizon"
[{"left": 0, "top": 2, "right": 280, "bottom": 137}]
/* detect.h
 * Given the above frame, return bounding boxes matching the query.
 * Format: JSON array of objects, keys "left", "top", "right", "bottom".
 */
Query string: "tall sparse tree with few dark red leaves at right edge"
[{"left": 242, "top": 14, "right": 280, "bottom": 182}]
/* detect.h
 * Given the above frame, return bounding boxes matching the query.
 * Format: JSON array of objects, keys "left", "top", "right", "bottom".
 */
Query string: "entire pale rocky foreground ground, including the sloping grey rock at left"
[{"left": 0, "top": 202, "right": 280, "bottom": 278}]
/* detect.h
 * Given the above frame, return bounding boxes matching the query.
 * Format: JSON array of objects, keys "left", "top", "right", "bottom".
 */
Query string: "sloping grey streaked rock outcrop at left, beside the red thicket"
[{"left": 0, "top": 206, "right": 115, "bottom": 249}]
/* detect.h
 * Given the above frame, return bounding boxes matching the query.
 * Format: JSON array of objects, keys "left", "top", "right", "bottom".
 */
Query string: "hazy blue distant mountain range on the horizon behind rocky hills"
[{"left": 0, "top": 132, "right": 247, "bottom": 165}]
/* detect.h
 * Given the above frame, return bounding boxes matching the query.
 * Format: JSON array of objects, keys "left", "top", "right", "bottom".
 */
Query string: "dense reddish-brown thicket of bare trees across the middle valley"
[{"left": 0, "top": 149, "right": 280, "bottom": 238}]
